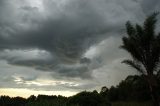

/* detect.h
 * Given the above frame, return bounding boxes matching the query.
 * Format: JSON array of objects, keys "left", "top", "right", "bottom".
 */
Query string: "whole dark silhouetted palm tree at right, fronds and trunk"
[{"left": 121, "top": 13, "right": 160, "bottom": 106}]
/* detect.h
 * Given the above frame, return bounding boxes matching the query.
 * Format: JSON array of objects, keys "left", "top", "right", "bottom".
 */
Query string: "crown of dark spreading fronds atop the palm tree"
[{"left": 120, "top": 13, "right": 160, "bottom": 74}]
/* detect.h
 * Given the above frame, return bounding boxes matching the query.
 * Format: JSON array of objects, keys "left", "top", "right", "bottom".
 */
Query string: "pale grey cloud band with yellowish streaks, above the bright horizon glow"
[{"left": 0, "top": 61, "right": 97, "bottom": 91}]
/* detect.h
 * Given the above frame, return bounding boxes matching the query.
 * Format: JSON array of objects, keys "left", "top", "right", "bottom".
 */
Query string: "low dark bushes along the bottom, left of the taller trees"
[{"left": 0, "top": 91, "right": 110, "bottom": 106}]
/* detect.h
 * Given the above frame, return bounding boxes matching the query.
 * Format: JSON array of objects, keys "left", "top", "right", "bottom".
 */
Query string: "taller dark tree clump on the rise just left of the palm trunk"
[{"left": 100, "top": 75, "right": 160, "bottom": 102}]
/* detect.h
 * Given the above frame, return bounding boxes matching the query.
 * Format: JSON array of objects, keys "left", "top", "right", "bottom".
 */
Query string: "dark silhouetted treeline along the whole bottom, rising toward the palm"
[{"left": 0, "top": 75, "right": 160, "bottom": 106}]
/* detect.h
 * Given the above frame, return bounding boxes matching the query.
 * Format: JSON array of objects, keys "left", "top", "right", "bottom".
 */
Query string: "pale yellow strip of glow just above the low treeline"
[{"left": 0, "top": 88, "right": 77, "bottom": 98}]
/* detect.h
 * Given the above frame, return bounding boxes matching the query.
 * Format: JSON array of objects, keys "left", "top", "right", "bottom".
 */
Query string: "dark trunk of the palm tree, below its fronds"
[{"left": 148, "top": 75, "right": 160, "bottom": 106}]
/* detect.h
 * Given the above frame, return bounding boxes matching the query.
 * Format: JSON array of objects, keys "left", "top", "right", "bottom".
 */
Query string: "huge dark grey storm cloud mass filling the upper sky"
[{"left": 0, "top": 0, "right": 158, "bottom": 81}]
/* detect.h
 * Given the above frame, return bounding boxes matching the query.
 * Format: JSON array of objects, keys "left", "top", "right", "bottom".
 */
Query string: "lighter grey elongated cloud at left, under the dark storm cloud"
[{"left": 0, "top": 49, "right": 57, "bottom": 68}]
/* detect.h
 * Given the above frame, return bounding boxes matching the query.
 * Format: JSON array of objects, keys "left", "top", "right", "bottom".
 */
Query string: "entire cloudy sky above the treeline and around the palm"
[{"left": 0, "top": 0, "right": 160, "bottom": 97}]
